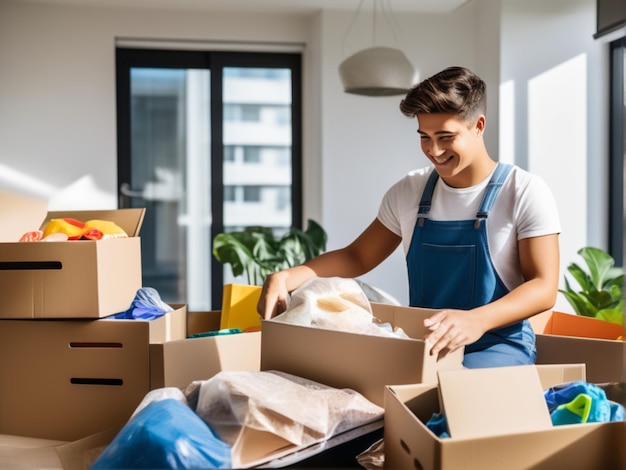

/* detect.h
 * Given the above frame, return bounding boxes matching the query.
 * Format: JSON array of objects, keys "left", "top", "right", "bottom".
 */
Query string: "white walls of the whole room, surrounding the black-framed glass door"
[{"left": 0, "top": 0, "right": 608, "bottom": 303}]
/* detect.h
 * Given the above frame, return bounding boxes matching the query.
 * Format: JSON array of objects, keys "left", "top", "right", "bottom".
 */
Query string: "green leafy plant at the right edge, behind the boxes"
[{"left": 559, "top": 247, "right": 624, "bottom": 325}]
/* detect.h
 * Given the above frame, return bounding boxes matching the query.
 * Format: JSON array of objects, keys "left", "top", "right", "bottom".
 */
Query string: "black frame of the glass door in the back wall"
[{"left": 115, "top": 46, "right": 303, "bottom": 310}]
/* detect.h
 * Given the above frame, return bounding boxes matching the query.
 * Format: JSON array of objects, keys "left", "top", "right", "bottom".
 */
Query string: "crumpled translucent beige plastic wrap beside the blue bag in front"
[{"left": 184, "top": 371, "right": 384, "bottom": 463}]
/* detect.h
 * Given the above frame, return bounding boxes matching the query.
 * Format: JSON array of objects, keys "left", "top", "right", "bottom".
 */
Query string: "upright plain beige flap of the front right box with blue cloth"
[{"left": 438, "top": 365, "right": 552, "bottom": 438}]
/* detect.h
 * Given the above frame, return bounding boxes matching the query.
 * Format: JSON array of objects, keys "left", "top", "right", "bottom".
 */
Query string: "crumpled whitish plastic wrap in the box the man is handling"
[{"left": 272, "top": 277, "right": 408, "bottom": 338}]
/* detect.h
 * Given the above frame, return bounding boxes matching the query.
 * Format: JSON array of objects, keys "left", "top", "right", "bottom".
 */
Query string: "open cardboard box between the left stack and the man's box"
[{"left": 150, "top": 311, "right": 261, "bottom": 389}]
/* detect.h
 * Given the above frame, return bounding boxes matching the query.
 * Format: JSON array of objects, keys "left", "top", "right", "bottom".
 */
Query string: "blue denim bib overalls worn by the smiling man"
[{"left": 406, "top": 163, "right": 536, "bottom": 368}]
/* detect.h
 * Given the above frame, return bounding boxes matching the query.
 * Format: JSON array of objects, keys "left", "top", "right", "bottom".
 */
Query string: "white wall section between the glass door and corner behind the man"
[{"left": 320, "top": 3, "right": 480, "bottom": 304}]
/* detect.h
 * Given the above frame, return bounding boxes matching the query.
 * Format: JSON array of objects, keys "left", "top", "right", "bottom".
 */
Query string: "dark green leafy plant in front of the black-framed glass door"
[{"left": 213, "top": 220, "right": 327, "bottom": 285}]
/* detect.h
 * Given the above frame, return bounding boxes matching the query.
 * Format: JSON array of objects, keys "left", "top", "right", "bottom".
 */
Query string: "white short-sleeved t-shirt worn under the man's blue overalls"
[{"left": 377, "top": 166, "right": 561, "bottom": 290}]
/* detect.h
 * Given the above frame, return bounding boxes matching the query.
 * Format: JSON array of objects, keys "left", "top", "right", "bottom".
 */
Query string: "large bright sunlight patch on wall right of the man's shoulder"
[{"left": 528, "top": 54, "right": 588, "bottom": 308}]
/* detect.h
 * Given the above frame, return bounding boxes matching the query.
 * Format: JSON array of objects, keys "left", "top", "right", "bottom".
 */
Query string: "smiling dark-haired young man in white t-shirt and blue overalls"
[{"left": 258, "top": 67, "right": 560, "bottom": 368}]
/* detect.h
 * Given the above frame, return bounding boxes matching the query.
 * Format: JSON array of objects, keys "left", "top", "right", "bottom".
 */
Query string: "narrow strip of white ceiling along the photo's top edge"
[{"left": 9, "top": 0, "right": 469, "bottom": 14}]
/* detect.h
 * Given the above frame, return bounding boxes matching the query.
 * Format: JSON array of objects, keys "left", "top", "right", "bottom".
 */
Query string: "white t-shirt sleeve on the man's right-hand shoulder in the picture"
[{"left": 517, "top": 175, "right": 561, "bottom": 240}]
